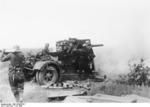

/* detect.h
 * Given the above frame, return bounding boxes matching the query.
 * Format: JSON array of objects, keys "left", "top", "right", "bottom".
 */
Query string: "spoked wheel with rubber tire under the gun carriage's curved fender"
[{"left": 38, "top": 65, "right": 58, "bottom": 85}]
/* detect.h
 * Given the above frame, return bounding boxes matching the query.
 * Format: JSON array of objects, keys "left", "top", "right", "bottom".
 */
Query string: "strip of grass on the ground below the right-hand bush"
[{"left": 88, "top": 80, "right": 150, "bottom": 98}]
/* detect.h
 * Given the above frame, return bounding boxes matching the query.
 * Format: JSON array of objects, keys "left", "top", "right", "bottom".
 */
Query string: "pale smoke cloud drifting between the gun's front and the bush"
[{"left": 94, "top": 27, "right": 150, "bottom": 76}]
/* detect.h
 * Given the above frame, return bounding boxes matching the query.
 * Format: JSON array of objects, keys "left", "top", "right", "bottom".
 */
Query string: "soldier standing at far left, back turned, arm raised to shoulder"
[{"left": 1, "top": 46, "right": 25, "bottom": 102}]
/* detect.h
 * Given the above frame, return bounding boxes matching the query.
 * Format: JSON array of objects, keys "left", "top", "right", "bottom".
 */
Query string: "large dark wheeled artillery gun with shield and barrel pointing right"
[{"left": 22, "top": 38, "right": 103, "bottom": 85}]
